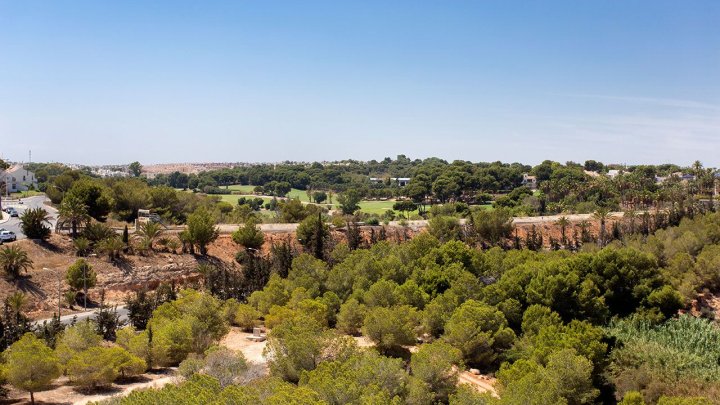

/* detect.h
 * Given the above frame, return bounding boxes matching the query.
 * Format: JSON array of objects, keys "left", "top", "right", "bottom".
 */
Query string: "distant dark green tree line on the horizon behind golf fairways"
[{"left": 146, "top": 155, "right": 715, "bottom": 215}]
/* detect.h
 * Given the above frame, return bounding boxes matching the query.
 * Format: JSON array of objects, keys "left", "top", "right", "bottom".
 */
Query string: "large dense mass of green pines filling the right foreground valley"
[{"left": 229, "top": 214, "right": 720, "bottom": 404}]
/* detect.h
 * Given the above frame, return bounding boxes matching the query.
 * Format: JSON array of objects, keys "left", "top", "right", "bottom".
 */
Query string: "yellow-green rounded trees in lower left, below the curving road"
[{"left": 0, "top": 290, "right": 231, "bottom": 402}]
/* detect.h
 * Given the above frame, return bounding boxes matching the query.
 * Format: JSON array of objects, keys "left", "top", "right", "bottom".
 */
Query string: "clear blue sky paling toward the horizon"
[{"left": 0, "top": 0, "right": 720, "bottom": 166}]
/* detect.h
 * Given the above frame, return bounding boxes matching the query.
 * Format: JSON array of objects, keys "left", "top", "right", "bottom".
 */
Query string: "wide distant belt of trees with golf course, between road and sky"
[{"left": 19, "top": 155, "right": 717, "bottom": 227}]
